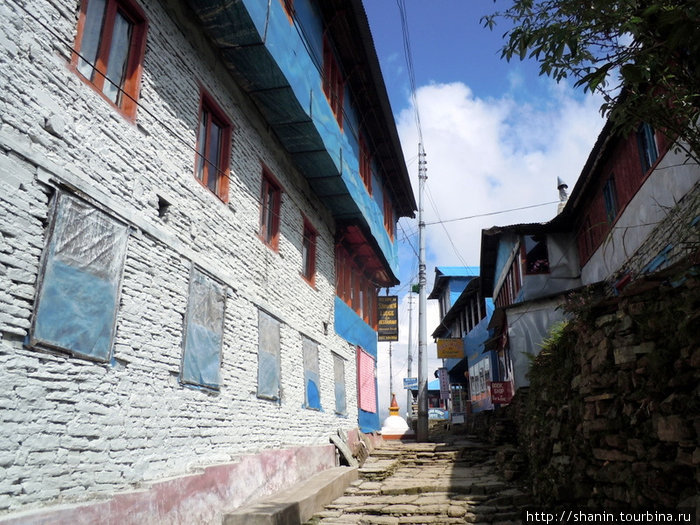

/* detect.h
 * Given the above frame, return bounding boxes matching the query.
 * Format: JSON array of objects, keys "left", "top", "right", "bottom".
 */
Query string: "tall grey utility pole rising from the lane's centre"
[{"left": 416, "top": 144, "right": 428, "bottom": 442}]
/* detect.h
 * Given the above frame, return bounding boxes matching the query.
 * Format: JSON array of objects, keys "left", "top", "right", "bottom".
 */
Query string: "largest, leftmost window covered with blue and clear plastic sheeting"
[{"left": 30, "top": 192, "right": 129, "bottom": 361}]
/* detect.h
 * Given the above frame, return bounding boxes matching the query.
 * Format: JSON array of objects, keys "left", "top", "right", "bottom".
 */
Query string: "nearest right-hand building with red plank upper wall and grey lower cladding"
[{"left": 481, "top": 117, "right": 700, "bottom": 398}]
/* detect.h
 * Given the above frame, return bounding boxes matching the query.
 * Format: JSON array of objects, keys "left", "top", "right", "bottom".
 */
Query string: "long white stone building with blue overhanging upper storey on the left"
[{"left": 0, "top": 0, "right": 416, "bottom": 523}]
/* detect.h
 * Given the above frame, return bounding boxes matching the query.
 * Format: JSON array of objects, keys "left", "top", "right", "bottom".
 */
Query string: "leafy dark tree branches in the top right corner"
[{"left": 482, "top": 0, "right": 700, "bottom": 161}]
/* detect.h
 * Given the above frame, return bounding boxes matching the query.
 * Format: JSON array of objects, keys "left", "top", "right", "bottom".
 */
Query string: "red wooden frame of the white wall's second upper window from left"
[{"left": 194, "top": 89, "right": 232, "bottom": 203}]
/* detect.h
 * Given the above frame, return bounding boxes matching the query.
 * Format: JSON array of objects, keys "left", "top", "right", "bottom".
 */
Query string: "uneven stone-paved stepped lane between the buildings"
[{"left": 309, "top": 441, "right": 529, "bottom": 525}]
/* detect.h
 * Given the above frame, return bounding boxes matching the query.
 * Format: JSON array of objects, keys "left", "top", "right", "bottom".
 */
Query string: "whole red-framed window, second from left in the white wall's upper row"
[{"left": 194, "top": 93, "right": 231, "bottom": 202}]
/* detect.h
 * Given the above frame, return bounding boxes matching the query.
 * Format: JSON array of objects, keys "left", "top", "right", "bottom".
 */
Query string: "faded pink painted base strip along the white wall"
[{"left": 0, "top": 445, "right": 336, "bottom": 525}]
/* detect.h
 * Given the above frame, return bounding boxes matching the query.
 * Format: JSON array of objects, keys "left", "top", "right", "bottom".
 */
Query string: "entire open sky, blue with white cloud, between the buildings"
[{"left": 364, "top": 0, "right": 603, "bottom": 418}]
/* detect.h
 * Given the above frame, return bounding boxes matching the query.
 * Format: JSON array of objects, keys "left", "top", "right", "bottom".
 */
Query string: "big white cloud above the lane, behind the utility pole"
[{"left": 378, "top": 77, "right": 603, "bottom": 421}]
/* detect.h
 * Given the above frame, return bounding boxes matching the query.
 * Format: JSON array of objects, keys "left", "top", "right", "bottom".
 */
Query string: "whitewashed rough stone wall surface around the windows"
[{"left": 0, "top": 0, "right": 357, "bottom": 516}]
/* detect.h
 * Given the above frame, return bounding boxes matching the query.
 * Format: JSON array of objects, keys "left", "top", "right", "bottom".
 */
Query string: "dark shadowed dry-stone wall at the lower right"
[{"left": 516, "top": 260, "right": 700, "bottom": 508}]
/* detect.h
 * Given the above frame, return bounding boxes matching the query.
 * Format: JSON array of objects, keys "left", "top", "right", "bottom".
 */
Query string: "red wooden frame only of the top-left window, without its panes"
[{"left": 71, "top": 0, "right": 148, "bottom": 121}]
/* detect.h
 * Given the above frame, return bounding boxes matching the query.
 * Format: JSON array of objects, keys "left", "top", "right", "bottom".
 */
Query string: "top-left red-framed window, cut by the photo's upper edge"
[{"left": 72, "top": 0, "right": 146, "bottom": 118}]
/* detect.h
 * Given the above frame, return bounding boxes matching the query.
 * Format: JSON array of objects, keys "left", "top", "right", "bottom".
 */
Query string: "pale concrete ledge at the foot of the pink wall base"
[{"left": 222, "top": 467, "right": 358, "bottom": 525}]
